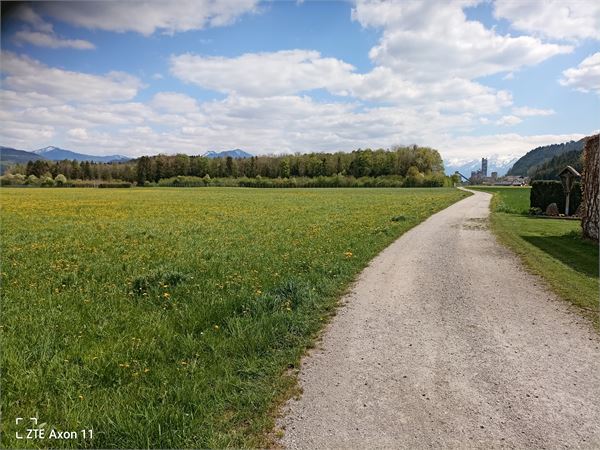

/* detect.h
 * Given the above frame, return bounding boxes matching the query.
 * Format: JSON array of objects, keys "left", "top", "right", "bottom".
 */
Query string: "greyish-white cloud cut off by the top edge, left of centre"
[{"left": 37, "top": 0, "right": 257, "bottom": 36}]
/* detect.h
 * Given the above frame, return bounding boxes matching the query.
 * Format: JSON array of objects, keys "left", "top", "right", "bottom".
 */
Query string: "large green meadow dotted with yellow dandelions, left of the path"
[{"left": 0, "top": 188, "right": 468, "bottom": 448}]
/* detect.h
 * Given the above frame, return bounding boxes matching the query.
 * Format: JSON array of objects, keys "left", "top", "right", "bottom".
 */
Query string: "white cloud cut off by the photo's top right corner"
[{"left": 494, "top": 0, "right": 600, "bottom": 39}]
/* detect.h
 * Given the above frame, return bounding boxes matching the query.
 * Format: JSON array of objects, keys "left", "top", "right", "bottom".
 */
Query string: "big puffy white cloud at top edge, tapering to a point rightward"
[{"left": 352, "top": 0, "right": 573, "bottom": 80}]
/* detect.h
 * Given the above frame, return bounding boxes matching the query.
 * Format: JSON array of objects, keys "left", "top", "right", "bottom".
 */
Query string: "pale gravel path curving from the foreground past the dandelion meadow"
[{"left": 279, "top": 192, "right": 600, "bottom": 449}]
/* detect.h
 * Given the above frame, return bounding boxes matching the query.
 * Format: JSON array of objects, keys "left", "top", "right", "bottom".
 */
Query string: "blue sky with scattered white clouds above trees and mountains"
[{"left": 0, "top": 0, "right": 600, "bottom": 163}]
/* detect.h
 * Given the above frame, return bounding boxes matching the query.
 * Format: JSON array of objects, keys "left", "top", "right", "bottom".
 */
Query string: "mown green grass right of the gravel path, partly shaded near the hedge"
[{"left": 476, "top": 187, "right": 600, "bottom": 330}]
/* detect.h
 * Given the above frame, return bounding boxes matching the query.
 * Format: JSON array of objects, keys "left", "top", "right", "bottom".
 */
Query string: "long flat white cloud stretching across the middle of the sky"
[{"left": 170, "top": 50, "right": 512, "bottom": 114}]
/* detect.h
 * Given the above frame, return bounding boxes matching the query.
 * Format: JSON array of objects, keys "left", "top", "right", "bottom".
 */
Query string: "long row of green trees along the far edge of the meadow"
[{"left": 3, "top": 145, "right": 460, "bottom": 186}]
